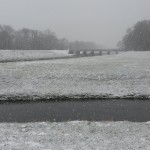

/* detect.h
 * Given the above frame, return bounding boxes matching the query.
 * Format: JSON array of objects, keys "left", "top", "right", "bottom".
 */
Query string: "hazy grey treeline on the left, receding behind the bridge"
[{"left": 0, "top": 25, "right": 96, "bottom": 50}]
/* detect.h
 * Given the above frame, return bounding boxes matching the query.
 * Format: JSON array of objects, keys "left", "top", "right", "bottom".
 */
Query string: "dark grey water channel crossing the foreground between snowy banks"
[{"left": 0, "top": 100, "right": 150, "bottom": 122}]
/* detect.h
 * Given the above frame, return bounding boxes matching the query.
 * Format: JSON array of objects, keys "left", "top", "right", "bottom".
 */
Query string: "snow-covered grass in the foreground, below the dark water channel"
[{"left": 0, "top": 121, "right": 150, "bottom": 150}]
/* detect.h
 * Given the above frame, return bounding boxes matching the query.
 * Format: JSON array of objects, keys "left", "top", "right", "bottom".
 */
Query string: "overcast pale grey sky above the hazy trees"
[{"left": 0, "top": 0, "right": 150, "bottom": 48}]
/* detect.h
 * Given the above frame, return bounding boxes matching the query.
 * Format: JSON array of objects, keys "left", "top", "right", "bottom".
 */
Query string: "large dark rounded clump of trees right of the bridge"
[{"left": 118, "top": 20, "right": 150, "bottom": 51}]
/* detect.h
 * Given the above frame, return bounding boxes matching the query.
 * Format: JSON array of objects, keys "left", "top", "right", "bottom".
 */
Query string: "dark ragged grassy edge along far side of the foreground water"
[{"left": 0, "top": 93, "right": 150, "bottom": 102}]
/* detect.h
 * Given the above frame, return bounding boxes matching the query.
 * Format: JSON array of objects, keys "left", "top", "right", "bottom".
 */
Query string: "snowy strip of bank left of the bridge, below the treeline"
[{"left": 0, "top": 50, "right": 72, "bottom": 62}]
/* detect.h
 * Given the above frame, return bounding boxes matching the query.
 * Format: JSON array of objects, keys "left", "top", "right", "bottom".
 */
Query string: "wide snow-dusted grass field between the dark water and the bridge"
[{"left": 0, "top": 52, "right": 150, "bottom": 100}]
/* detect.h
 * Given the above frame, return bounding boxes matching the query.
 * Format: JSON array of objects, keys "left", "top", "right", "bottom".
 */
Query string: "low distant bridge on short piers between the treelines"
[{"left": 69, "top": 49, "right": 126, "bottom": 56}]
